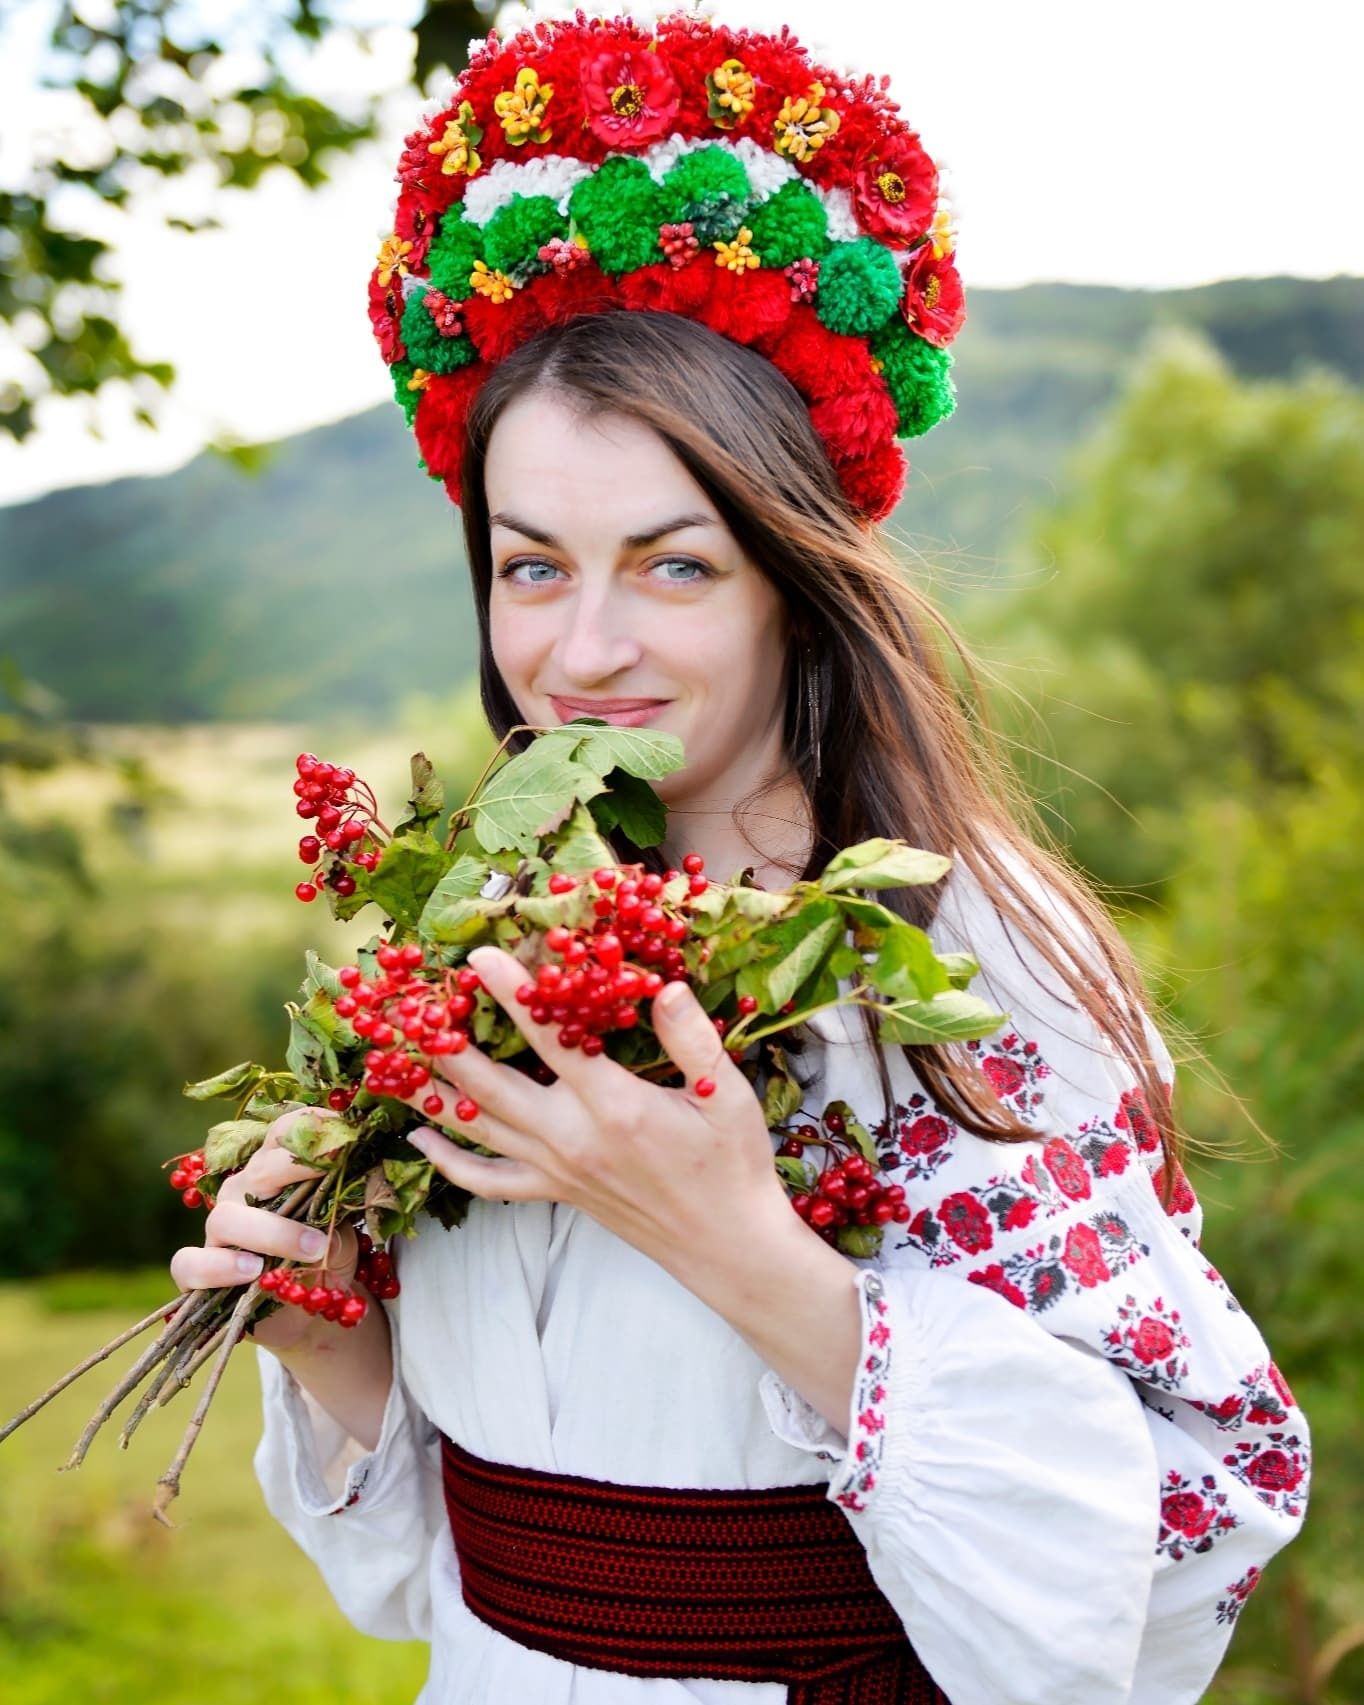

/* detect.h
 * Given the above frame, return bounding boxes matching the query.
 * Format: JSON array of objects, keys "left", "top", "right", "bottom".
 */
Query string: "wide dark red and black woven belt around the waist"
[{"left": 442, "top": 1434, "right": 950, "bottom": 1705}]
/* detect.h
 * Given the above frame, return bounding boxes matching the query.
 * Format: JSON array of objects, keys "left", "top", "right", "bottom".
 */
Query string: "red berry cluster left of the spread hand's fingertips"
[{"left": 327, "top": 941, "right": 481, "bottom": 1120}]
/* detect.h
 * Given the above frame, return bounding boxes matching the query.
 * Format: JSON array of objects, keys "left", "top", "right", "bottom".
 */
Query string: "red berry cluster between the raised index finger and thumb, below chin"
[{"left": 504, "top": 866, "right": 709, "bottom": 1055}]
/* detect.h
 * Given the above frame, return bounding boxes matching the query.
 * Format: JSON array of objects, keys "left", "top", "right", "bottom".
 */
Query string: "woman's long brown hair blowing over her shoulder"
[{"left": 460, "top": 309, "right": 1185, "bottom": 1211}]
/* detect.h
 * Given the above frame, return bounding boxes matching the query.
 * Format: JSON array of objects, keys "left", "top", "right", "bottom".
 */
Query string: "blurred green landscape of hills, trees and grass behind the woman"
[{"left": 0, "top": 3, "right": 1364, "bottom": 1705}]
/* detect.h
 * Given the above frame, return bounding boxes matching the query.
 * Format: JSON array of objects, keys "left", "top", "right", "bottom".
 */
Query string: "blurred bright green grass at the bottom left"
[{"left": 0, "top": 1270, "right": 428, "bottom": 1705}]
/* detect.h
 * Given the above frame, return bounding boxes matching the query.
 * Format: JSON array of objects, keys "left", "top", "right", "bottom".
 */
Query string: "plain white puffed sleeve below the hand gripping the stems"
[{"left": 254, "top": 1295, "right": 445, "bottom": 1640}]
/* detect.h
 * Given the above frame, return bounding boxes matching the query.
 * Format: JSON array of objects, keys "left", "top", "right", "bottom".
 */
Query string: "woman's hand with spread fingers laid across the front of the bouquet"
[{"left": 397, "top": 948, "right": 787, "bottom": 1277}]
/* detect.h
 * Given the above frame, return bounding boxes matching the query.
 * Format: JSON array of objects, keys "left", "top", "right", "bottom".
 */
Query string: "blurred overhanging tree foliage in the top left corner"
[{"left": 0, "top": 0, "right": 493, "bottom": 440}]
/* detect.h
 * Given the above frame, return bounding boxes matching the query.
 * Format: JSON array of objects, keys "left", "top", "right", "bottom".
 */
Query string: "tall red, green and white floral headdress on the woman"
[{"left": 370, "top": 10, "right": 965, "bottom": 520}]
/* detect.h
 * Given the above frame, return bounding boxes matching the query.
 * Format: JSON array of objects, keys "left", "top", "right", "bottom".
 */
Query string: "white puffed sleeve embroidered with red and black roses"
[{"left": 764, "top": 859, "right": 1309, "bottom": 1705}]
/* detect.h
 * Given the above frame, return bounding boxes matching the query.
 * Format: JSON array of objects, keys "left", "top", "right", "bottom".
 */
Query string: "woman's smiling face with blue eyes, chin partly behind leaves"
[{"left": 484, "top": 392, "right": 788, "bottom": 803}]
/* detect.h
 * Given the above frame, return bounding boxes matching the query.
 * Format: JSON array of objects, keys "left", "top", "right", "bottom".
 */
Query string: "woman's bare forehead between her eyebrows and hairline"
[{"left": 484, "top": 392, "right": 720, "bottom": 537}]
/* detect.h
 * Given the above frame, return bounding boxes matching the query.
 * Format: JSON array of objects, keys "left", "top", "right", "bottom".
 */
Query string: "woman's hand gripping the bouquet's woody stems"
[{"left": 171, "top": 1108, "right": 360, "bottom": 1350}]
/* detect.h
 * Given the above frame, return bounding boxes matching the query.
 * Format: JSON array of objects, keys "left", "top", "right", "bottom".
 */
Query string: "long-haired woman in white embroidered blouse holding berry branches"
[{"left": 172, "top": 6, "right": 1308, "bottom": 1705}]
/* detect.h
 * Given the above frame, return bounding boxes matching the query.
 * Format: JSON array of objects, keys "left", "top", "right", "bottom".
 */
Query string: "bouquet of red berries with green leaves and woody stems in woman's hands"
[{"left": 0, "top": 720, "right": 1004, "bottom": 1524}]
